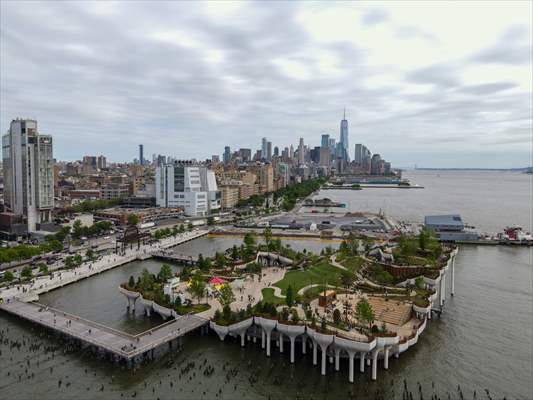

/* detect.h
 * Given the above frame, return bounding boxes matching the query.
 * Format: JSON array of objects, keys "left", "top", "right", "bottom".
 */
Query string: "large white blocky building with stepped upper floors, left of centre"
[{"left": 155, "top": 161, "right": 220, "bottom": 217}]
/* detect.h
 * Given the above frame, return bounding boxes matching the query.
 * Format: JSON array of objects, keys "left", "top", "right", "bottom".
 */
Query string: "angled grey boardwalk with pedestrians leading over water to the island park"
[{"left": 0, "top": 300, "right": 208, "bottom": 361}]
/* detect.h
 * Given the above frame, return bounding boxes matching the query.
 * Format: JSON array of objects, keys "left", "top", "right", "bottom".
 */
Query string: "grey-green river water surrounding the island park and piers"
[{"left": 0, "top": 172, "right": 533, "bottom": 399}]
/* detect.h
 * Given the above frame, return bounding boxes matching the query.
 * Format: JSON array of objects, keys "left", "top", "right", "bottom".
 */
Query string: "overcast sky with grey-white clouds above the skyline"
[{"left": 0, "top": 1, "right": 533, "bottom": 167}]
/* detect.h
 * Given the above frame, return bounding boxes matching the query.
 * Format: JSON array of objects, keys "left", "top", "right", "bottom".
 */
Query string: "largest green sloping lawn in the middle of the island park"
[{"left": 274, "top": 262, "right": 342, "bottom": 294}]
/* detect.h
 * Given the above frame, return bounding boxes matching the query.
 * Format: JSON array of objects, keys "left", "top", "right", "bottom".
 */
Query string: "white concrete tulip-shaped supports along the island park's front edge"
[{"left": 209, "top": 316, "right": 426, "bottom": 382}]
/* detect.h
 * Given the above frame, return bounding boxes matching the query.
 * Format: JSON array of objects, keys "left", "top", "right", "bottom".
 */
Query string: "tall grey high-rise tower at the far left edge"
[{"left": 2, "top": 119, "right": 54, "bottom": 232}]
